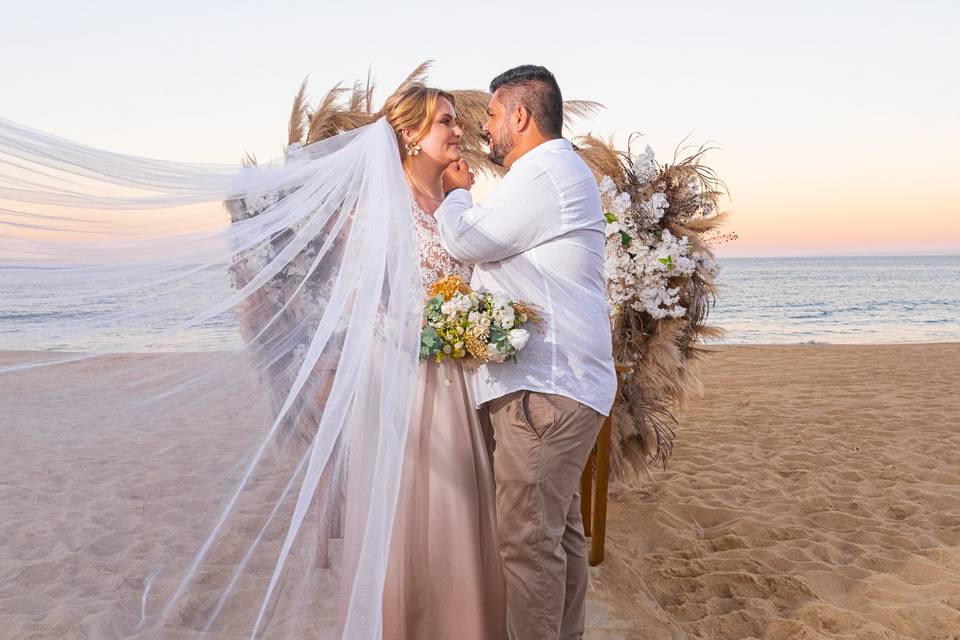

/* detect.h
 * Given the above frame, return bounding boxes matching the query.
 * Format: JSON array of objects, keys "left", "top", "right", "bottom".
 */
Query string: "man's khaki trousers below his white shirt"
[{"left": 481, "top": 391, "right": 603, "bottom": 640}]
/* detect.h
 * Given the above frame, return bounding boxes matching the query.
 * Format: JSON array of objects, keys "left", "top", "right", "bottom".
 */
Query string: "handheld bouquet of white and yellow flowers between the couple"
[{"left": 420, "top": 276, "right": 540, "bottom": 363}]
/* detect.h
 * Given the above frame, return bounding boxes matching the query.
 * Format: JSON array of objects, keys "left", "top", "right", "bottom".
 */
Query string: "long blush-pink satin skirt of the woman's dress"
[{"left": 383, "top": 361, "right": 506, "bottom": 640}]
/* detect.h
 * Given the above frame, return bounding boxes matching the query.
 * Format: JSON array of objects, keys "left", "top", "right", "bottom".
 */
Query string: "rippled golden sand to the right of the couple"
[{"left": 588, "top": 343, "right": 960, "bottom": 640}]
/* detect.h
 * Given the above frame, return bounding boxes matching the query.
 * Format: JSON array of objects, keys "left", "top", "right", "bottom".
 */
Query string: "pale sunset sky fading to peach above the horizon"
[{"left": 0, "top": 0, "right": 960, "bottom": 256}]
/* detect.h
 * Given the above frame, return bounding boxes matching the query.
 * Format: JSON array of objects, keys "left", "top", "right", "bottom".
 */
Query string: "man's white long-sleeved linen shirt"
[{"left": 434, "top": 138, "right": 617, "bottom": 415}]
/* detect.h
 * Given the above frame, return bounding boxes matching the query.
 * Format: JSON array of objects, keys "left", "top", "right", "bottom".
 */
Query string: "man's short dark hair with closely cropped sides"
[{"left": 490, "top": 64, "right": 563, "bottom": 138}]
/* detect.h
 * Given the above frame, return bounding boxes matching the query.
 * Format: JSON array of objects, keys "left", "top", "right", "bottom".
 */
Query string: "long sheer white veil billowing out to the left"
[{"left": 0, "top": 112, "right": 422, "bottom": 640}]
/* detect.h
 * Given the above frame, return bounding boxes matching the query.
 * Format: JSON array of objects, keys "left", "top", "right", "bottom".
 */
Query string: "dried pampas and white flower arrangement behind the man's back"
[{"left": 576, "top": 136, "right": 736, "bottom": 479}]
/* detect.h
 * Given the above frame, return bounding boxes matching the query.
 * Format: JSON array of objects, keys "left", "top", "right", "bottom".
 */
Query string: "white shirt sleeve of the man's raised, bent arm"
[{"left": 434, "top": 162, "right": 563, "bottom": 264}]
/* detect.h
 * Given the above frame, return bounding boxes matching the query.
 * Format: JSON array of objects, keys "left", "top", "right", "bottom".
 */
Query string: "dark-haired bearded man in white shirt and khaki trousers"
[{"left": 435, "top": 65, "right": 617, "bottom": 640}]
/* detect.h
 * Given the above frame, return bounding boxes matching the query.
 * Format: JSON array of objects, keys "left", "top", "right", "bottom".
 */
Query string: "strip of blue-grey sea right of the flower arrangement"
[{"left": 709, "top": 256, "right": 960, "bottom": 344}]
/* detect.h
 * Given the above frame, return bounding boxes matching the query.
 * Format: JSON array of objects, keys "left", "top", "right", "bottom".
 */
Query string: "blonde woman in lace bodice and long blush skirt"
[{"left": 384, "top": 84, "right": 505, "bottom": 640}]
